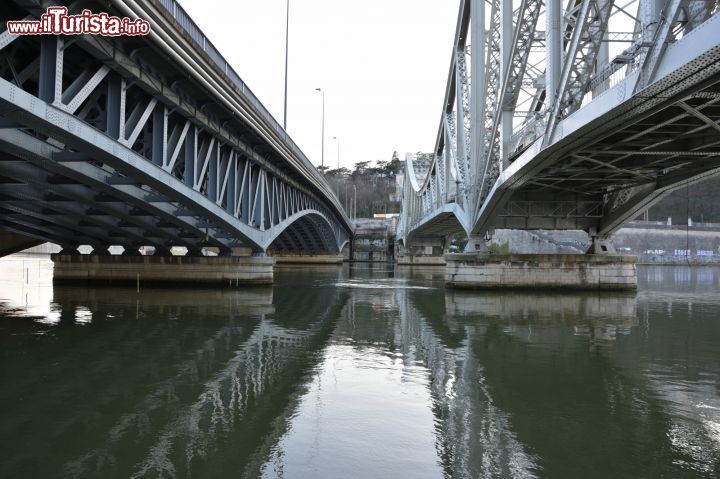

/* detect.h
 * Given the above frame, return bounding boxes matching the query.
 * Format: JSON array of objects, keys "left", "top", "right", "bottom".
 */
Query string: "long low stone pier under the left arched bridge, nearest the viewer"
[{"left": 51, "top": 250, "right": 275, "bottom": 287}]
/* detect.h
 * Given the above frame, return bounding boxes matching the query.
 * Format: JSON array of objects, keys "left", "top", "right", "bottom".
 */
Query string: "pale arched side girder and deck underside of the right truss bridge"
[{"left": 475, "top": 10, "right": 720, "bottom": 237}]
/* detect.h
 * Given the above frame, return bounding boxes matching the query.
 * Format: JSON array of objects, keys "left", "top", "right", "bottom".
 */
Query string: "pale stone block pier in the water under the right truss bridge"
[{"left": 445, "top": 253, "right": 637, "bottom": 290}]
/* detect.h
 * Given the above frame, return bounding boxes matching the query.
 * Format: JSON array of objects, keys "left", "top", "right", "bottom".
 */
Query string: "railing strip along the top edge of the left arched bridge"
[{"left": 159, "top": 0, "right": 344, "bottom": 217}]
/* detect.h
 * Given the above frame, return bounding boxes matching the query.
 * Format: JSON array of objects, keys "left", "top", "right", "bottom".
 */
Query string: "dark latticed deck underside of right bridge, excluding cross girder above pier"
[{"left": 517, "top": 92, "right": 720, "bottom": 204}]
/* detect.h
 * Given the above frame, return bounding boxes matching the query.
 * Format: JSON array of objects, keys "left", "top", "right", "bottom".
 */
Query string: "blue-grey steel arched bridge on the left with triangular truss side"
[{"left": 0, "top": 0, "right": 353, "bottom": 254}]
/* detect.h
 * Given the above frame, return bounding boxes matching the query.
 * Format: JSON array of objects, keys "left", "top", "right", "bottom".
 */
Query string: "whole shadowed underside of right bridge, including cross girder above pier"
[{"left": 496, "top": 76, "right": 720, "bottom": 235}]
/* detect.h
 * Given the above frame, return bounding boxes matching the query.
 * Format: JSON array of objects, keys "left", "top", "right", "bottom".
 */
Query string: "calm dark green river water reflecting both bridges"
[{"left": 0, "top": 257, "right": 720, "bottom": 478}]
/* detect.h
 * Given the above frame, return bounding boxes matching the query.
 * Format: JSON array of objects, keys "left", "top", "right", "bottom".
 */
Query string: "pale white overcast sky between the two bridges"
[{"left": 181, "top": 0, "right": 459, "bottom": 169}]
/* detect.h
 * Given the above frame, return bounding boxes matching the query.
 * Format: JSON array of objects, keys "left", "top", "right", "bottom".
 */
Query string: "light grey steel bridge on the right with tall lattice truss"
[{"left": 398, "top": 0, "right": 720, "bottom": 252}]
